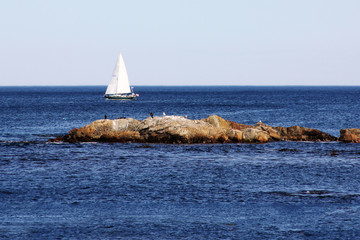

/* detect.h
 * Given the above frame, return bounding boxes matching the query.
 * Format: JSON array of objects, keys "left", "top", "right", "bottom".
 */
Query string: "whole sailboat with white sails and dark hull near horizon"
[{"left": 104, "top": 53, "right": 139, "bottom": 100}]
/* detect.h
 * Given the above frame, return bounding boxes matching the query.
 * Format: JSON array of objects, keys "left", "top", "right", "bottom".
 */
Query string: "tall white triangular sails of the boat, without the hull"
[{"left": 105, "top": 53, "right": 131, "bottom": 94}]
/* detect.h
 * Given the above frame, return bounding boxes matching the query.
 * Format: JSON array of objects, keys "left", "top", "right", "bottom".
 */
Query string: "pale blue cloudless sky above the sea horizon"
[{"left": 0, "top": 0, "right": 360, "bottom": 86}]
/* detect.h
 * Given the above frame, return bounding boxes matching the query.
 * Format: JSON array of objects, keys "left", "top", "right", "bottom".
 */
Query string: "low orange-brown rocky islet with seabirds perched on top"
[{"left": 51, "top": 115, "right": 360, "bottom": 144}]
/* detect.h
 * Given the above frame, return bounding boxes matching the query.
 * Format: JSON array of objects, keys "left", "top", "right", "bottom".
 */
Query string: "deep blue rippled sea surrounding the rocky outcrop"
[{"left": 0, "top": 87, "right": 360, "bottom": 239}]
